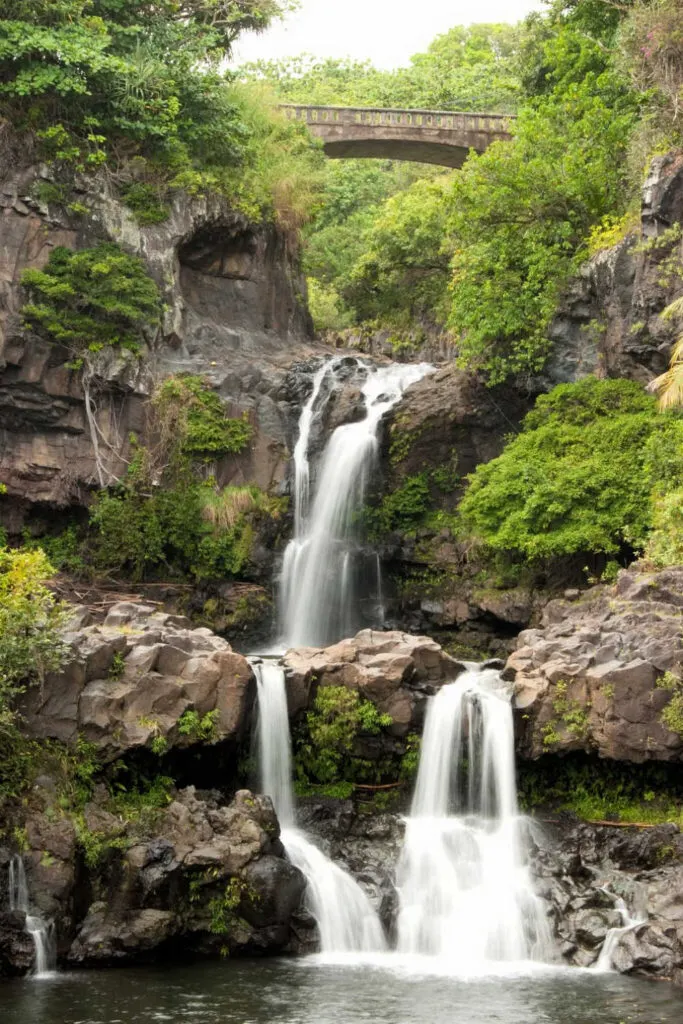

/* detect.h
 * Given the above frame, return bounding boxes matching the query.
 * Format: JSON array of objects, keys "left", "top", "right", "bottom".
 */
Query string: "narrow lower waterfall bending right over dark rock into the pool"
[{"left": 252, "top": 660, "right": 385, "bottom": 954}]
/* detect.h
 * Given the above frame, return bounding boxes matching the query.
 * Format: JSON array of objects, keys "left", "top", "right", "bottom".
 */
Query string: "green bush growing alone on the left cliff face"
[{"left": 22, "top": 242, "right": 161, "bottom": 355}]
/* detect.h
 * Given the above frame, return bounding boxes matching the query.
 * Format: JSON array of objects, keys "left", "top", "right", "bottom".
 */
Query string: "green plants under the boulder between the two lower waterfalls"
[{"left": 295, "top": 686, "right": 392, "bottom": 796}]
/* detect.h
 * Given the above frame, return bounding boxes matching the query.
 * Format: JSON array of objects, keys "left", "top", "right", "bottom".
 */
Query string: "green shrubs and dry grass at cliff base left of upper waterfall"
[{"left": 90, "top": 376, "right": 270, "bottom": 580}]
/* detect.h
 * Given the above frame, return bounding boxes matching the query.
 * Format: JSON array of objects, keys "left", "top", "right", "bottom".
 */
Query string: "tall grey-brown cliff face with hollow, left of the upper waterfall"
[{"left": 0, "top": 163, "right": 319, "bottom": 532}]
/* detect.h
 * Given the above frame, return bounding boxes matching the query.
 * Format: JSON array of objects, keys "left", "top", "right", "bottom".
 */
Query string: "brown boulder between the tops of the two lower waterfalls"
[{"left": 284, "top": 630, "right": 463, "bottom": 737}]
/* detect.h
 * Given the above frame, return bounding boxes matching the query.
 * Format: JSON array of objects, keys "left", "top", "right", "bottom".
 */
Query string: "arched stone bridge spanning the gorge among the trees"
[{"left": 282, "top": 103, "right": 514, "bottom": 167}]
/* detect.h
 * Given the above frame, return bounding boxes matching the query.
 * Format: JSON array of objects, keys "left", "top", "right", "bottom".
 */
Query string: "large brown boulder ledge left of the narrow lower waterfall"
[{"left": 22, "top": 602, "right": 255, "bottom": 761}]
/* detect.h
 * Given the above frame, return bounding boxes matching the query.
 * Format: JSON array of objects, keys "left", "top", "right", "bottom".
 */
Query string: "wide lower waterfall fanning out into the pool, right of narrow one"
[{"left": 397, "top": 667, "right": 552, "bottom": 968}]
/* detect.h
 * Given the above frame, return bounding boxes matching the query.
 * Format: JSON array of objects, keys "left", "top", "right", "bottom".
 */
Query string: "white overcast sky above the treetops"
[{"left": 234, "top": 0, "right": 544, "bottom": 68}]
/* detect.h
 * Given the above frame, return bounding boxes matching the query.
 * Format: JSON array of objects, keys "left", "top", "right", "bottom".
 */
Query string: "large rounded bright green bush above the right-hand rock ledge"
[{"left": 459, "top": 377, "right": 683, "bottom": 560}]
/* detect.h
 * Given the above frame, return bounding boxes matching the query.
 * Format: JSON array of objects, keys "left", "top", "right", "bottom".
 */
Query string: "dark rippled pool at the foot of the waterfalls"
[{"left": 0, "top": 958, "right": 683, "bottom": 1024}]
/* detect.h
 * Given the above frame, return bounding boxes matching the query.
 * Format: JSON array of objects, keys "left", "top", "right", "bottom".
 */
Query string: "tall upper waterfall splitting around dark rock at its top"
[{"left": 280, "top": 359, "right": 432, "bottom": 647}]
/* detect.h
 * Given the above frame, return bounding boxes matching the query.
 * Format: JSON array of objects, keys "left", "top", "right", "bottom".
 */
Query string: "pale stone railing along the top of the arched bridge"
[{"left": 281, "top": 103, "right": 515, "bottom": 135}]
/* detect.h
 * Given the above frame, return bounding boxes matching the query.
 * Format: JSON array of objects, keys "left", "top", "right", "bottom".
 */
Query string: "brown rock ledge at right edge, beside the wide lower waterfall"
[{"left": 506, "top": 566, "right": 683, "bottom": 762}]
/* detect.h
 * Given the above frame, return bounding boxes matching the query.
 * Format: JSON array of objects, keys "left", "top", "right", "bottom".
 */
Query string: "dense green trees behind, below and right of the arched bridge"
[{"left": 243, "top": 0, "right": 683, "bottom": 383}]
